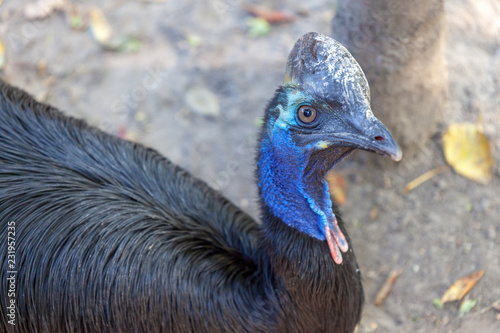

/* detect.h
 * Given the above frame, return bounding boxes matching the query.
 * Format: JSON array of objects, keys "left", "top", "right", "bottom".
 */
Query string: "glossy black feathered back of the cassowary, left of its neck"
[{"left": 0, "top": 83, "right": 262, "bottom": 332}]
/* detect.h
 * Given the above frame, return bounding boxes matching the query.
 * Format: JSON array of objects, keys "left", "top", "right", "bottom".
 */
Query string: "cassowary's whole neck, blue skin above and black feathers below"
[{"left": 257, "top": 100, "right": 363, "bottom": 332}]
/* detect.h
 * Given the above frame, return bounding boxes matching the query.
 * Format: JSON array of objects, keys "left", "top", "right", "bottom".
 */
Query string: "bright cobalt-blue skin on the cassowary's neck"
[{"left": 258, "top": 131, "right": 334, "bottom": 240}]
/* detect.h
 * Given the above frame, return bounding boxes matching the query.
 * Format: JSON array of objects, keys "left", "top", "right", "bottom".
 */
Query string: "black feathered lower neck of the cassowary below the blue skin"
[{"left": 260, "top": 208, "right": 363, "bottom": 332}]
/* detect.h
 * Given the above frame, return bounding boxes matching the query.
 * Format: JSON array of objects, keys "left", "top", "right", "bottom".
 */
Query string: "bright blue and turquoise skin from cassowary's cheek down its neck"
[{"left": 258, "top": 88, "right": 344, "bottom": 241}]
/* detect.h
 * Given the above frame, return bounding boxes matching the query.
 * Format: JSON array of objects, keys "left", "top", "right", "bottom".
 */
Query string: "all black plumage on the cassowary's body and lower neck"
[{"left": 0, "top": 32, "right": 400, "bottom": 333}]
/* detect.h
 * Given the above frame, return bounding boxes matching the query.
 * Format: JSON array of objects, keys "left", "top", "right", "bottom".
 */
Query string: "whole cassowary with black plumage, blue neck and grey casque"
[{"left": 0, "top": 33, "right": 401, "bottom": 333}]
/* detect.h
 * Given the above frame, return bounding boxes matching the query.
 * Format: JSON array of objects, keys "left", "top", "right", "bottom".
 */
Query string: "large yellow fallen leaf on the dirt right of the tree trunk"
[{"left": 443, "top": 123, "right": 494, "bottom": 184}]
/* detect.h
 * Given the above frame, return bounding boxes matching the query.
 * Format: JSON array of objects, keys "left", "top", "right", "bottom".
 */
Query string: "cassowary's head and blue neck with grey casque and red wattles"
[{"left": 258, "top": 33, "right": 402, "bottom": 264}]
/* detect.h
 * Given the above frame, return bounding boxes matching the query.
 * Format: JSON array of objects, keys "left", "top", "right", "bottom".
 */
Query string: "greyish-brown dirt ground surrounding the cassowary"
[{"left": 0, "top": 0, "right": 500, "bottom": 332}]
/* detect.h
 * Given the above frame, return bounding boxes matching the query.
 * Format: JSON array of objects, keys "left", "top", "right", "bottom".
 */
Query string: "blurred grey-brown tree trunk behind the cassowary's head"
[{"left": 333, "top": 0, "right": 448, "bottom": 157}]
